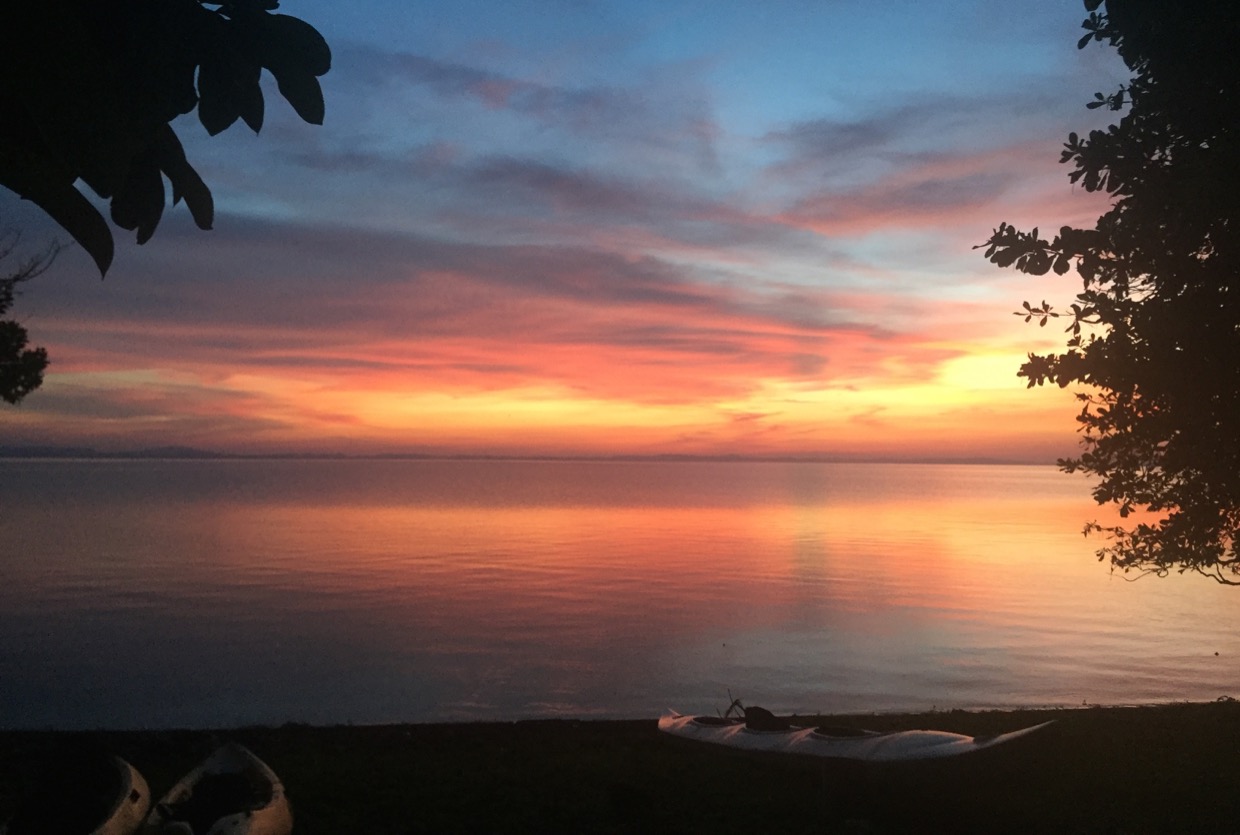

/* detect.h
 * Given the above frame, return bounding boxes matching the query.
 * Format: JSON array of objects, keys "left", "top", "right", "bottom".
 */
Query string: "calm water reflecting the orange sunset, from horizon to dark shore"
[{"left": 0, "top": 460, "right": 1240, "bottom": 728}]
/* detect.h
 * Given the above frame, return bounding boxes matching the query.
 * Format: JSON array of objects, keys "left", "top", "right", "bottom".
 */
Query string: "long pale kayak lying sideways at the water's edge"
[{"left": 658, "top": 708, "right": 1050, "bottom": 763}]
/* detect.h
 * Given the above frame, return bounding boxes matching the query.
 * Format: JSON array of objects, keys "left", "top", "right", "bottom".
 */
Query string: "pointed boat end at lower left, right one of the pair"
[{"left": 141, "top": 743, "right": 293, "bottom": 835}]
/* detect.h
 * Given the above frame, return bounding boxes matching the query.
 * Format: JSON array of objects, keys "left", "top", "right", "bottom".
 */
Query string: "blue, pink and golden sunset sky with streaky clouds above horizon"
[{"left": 0, "top": 0, "right": 1126, "bottom": 460}]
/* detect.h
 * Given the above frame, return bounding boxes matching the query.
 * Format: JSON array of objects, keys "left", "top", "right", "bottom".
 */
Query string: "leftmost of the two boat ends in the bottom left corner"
[{"left": 0, "top": 754, "right": 151, "bottom": 835}]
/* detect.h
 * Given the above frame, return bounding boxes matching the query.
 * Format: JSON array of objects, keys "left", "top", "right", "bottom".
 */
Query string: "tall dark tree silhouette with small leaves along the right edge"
[{"left": 978, "top": 0, "right": 1240, "bottom": 584}]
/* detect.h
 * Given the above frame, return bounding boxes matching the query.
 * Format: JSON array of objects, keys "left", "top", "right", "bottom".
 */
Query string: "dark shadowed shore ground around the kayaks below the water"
[{"left": 0, "top": 702, "right": 1240, "bottom": 835}]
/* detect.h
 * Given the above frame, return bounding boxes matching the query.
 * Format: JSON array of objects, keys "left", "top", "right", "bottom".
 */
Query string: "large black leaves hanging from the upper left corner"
[{"left": 0, "top": 0, "right": 331, "bottom": 274}]
